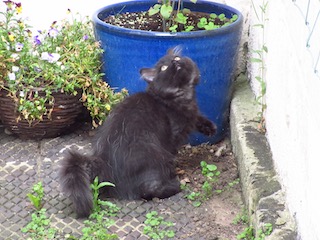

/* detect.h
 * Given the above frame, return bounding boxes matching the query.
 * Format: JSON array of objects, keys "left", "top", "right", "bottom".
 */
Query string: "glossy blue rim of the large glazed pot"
[{"left": 92, "top": 0, "right": 243, "bottom": 38}]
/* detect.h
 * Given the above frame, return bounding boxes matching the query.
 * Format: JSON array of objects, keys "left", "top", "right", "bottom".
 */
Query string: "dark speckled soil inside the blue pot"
[{"left": 104, "top": 11, "right": 236, "bottom": 32}]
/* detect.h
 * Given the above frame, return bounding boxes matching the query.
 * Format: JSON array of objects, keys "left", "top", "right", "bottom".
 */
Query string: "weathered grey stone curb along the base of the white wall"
[{"left": 230, "top": 74, "right": 297, "bottom": 240}]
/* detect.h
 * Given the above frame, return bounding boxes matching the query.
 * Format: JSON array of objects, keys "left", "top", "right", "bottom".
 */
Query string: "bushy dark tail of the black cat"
[{"left": 59, "top": 151, "right": 105, "bottom": 217}]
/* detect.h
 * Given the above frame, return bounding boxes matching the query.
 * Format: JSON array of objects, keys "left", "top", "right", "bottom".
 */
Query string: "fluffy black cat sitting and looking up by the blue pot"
[{"left": 59, "top": 49, "right": 216, "bottom": 217}]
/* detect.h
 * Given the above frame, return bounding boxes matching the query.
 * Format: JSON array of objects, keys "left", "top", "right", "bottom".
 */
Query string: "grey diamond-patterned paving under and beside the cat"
[{"left": 0, "top": 127, "right": 230, "bottom": 240}]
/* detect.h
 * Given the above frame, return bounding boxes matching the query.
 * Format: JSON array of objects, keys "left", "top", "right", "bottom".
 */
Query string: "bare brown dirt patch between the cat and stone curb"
[{"left": 177, "top": 139, "right": 244, "bottom": 240}]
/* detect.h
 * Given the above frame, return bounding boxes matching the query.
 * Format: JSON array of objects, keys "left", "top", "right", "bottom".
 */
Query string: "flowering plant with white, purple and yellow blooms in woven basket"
[{"left": 0, "top": 0, "right": 127, "bottom": 127}]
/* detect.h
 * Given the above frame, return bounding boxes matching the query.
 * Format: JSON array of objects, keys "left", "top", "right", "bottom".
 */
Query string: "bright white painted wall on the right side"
[{"left": 249, "top": 0, "right": 320, "bottom": 240}]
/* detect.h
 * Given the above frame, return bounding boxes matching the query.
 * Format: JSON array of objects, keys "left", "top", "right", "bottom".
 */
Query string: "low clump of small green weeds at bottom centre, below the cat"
[{"left": 143, "top": 211, "right": 175, "bottom": 239}]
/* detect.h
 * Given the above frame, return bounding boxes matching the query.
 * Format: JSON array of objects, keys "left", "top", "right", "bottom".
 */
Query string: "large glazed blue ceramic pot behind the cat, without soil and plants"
[{"left": 93, "top": 0, "right": 243, "bottom": 145}]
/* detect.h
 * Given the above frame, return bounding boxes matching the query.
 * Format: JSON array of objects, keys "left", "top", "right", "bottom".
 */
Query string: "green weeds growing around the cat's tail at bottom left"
[{"left": 21, "top": 177, "right": 119, "bottom": 240}]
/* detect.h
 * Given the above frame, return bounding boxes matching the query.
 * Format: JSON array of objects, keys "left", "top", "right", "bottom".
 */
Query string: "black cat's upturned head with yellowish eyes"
[{"left": 140, "top": 48, "right": 200, "bottom": 100}]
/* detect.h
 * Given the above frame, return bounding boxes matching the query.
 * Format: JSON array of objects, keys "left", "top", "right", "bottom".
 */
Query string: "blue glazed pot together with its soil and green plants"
[{"left": 93, "top": 0, "right": 243, "bottom": 145}]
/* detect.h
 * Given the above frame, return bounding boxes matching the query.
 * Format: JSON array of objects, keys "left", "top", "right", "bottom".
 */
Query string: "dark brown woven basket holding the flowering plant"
[{"left": 0, "top": 89, "right": 83, "bottom": 139}]
